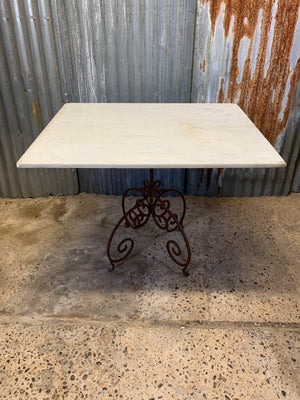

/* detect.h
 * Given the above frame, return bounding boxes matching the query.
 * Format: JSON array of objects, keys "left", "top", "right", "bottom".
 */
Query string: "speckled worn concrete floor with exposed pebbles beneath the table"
[{"left": 0, "top": 194, "right": 300, "bottom": 400}]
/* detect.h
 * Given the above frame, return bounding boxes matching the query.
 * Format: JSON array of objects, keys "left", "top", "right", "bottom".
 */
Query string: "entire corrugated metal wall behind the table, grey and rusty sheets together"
[{"left": 0, "top": 0, "right": 300, "bottom": 197}]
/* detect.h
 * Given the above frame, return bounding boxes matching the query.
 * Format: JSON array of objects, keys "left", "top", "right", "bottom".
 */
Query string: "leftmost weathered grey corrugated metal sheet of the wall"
[{"left": 0, "top": 0, "right": 78, "bottom": 197}]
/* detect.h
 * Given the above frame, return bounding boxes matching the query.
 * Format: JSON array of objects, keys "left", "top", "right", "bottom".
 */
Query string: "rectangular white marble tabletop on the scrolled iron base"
[{"left": 17, "top": 103, "right": 286, "bottom": 168}]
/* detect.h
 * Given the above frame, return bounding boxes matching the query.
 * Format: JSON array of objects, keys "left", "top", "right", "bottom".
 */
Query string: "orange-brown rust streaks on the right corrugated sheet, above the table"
[{"left": 200, "top": 0, "right": 300, "bottom": 143}]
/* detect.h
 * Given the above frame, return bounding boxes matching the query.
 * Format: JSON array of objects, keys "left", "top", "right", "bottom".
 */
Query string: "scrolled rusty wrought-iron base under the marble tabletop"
[{"left": 107, "top": 169, "right": 191, "bottom": 276}]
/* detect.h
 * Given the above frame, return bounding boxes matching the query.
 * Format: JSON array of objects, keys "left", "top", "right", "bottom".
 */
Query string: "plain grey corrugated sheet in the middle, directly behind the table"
[{"left": 73, "top": 0, "right": 196, "bottom": 194}]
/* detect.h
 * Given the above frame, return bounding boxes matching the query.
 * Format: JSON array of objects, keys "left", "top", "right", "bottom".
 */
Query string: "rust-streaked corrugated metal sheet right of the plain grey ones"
[{"left": 190, "top": 0, "right": 300, "bottom": 196}]
